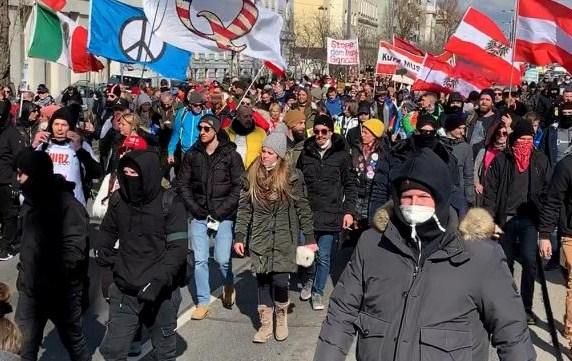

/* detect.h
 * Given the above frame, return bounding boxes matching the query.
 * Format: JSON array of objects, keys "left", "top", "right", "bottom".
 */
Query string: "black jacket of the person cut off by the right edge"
[{"left": 538, "top": 154, "right": 572, "bottom": 239}]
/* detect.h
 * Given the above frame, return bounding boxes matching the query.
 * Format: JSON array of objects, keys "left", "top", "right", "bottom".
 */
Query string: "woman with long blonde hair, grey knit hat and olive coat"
[{"left": 234, "top": 132, "right": 317, "bottom": 343}]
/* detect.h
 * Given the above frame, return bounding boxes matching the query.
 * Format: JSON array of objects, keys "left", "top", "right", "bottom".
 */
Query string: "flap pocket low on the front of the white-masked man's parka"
[{"left": 420, "top": 328, "right": 473, "bottom": 361}]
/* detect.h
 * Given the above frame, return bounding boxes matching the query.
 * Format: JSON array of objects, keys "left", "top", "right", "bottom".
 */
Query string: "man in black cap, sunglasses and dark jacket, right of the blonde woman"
[{"left": 298, "top": 115, "right": 357, "bottom": 310}]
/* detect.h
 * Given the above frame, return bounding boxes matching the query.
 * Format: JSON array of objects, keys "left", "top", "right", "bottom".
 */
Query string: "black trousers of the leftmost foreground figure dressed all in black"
[{"left": 16, "top": 287, "right": 91, "bottom": 361}]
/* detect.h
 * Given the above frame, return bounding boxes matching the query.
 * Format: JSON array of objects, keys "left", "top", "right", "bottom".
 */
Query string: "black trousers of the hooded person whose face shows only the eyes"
[{"left": 99, "top": 283, "right": 181, "bottom": 361}]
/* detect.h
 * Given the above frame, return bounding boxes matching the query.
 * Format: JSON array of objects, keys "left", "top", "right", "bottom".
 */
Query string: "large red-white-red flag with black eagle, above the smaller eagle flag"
[{"left": 445, "top": 5, "right": 520, "bottom": 84}]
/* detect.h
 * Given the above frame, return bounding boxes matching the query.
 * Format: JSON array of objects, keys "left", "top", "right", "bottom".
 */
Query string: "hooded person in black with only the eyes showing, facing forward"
[{"left": 96, "top": 151, "right": 187, "bottom": 361}]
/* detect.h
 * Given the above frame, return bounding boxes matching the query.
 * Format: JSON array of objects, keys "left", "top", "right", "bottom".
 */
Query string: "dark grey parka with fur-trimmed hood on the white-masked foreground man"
[{"left": 314, "top": 205, "right": 536, "bottom": 361}]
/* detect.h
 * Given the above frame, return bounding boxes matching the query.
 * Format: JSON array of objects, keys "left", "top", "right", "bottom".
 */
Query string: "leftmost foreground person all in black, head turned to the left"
[{"left": 16, "top": 150, "right": 91, "bottom": 361}]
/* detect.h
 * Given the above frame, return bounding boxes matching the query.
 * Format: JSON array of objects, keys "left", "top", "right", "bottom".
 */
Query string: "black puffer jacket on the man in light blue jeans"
[{"left": 177, "top": 131, "right": 244, "bottom": 222}]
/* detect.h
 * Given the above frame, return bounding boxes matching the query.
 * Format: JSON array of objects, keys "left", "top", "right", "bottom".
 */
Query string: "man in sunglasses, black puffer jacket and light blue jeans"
[{"left": 177, "top": 114, "right": 244, "bottom": 320}]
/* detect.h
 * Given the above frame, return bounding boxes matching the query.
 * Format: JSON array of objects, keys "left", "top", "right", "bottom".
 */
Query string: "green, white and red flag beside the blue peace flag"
[{"left": 28, "top": 4, "right": 103, "bottom": 73}]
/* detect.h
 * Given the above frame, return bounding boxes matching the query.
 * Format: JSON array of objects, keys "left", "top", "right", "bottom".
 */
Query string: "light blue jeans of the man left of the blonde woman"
[{"left": 189, "top": 219, "right": 234, "bottom": 305}]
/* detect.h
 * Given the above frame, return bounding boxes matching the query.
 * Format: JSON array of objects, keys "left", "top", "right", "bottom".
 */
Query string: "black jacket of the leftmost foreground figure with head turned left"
[{"left": 18, "top": 175, "right": 89, "bottom": 295}]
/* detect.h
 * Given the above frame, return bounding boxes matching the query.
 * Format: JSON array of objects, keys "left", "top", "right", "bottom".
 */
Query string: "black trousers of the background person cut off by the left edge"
[{"left": 0, "top": 184, "right": 20, "bottom": 252}]
